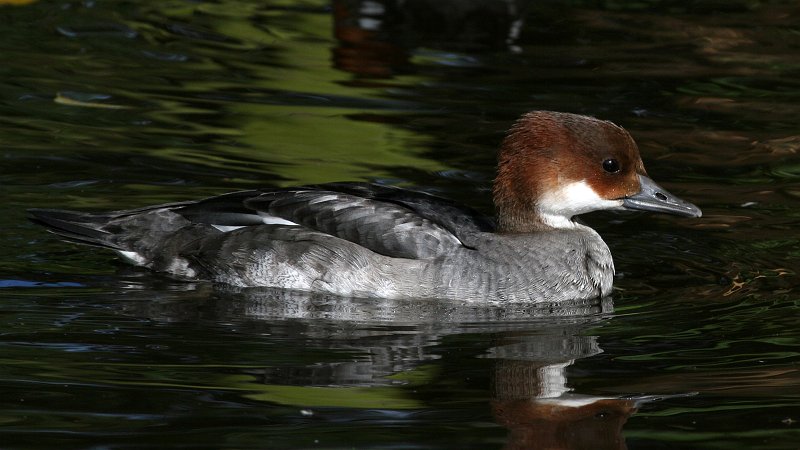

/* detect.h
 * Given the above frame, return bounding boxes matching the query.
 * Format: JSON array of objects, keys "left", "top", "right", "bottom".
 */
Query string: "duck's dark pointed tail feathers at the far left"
[{"left": 28, "top": 209, "right": 122, "bottom": 250}]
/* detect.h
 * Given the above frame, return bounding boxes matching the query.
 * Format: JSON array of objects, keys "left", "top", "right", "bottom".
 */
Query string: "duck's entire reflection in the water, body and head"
[{"left": 115, "top": 286, "right": 692, "bottom": 449}]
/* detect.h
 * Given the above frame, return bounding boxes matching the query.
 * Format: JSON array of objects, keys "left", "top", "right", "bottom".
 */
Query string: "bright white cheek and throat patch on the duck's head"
[{"left": 536, "top": 180, "right": 622, "bottom": 228}]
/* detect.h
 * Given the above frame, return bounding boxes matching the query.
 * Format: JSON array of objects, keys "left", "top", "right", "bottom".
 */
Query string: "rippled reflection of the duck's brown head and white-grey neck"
[{"left": 489, "top": 327, "right": 637, "bottom": 449}]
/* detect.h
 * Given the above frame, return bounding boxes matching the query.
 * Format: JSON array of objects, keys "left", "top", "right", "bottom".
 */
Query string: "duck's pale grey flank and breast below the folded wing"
[{"left": 184, "top": 225, "right": 614, "bottom": 302}]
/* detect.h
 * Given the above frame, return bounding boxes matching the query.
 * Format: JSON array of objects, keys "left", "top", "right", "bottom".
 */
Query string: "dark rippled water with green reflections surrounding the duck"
[{"left": 0, "top": 0, "right": 800, "bottom": 449}]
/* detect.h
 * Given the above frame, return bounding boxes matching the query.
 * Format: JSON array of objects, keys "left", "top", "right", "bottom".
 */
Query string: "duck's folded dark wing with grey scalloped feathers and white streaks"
[{"left": 178, "top": 183, "right": 493, "bottom": 259}]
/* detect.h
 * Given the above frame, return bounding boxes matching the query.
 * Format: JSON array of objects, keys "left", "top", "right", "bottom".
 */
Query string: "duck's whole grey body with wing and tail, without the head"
[{"left": 32, "top": 184, "right": 614, "bottom": 302}]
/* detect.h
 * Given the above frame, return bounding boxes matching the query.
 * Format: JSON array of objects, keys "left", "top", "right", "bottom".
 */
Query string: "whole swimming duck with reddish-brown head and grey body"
[{"left": 29, "top": 111, "right": 702, "bottom": 303}]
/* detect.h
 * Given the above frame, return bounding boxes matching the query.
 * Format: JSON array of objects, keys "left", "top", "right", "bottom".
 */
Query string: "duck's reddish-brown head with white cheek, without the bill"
[{"left": 494, "top": 111, "right": 646, "bottom": 232}]
